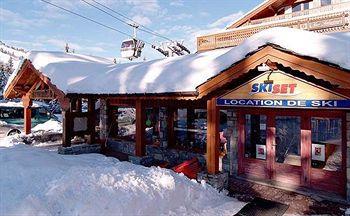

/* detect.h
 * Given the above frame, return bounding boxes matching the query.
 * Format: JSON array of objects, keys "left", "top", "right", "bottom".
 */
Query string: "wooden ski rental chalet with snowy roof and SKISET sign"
[{"left": 4, "top": 20, "right": 350, "bottom": 202}]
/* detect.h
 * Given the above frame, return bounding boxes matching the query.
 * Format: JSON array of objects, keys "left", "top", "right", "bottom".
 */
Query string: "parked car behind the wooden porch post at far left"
[{"left": 0, "top": 102, "right": 58, "bottom": 138}]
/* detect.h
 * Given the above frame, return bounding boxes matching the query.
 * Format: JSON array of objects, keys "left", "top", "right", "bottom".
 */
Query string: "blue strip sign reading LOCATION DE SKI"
[{"left": 216, "top": 98, "right": 350, "bottom": 109}]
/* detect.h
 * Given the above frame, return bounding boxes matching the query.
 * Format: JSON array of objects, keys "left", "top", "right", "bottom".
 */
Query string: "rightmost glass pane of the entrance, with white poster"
[{"left": 311, "top": 118, "right": 342, "bottom": 171}]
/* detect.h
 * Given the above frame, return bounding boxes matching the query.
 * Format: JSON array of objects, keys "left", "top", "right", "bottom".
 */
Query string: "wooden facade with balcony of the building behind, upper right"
[{"left": 197, "top": 0, "right": 350, "bottom": 51}]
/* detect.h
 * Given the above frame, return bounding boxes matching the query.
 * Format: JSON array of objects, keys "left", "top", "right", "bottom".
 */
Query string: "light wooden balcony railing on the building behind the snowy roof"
[{"left": 197, "top": 2, "right": 350, "bottom": 51}]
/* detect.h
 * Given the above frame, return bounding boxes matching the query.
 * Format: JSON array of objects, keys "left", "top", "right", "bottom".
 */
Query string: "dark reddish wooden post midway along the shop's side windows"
[{"left": 135, "top": 100, "right": 146, "bottom": 157}]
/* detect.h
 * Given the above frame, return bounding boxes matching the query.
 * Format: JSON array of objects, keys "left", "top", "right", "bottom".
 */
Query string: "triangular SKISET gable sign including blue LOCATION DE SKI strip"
[{"left": 217, "top": 72, "right": 350, "bottom": 109}]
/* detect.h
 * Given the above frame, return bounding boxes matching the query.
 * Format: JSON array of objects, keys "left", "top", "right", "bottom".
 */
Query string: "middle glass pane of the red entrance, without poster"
[{"left": 275, "top": 116, "right": 301, "bottom": 166}]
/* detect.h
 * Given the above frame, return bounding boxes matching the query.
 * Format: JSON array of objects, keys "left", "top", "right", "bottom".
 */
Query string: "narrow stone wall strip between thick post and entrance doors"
[{"left": 223, "top": 110, "right": 238, "bottom": 175}]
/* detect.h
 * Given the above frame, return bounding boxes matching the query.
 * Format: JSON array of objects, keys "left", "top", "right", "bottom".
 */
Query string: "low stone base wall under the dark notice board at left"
[{"left": 58, "top": 144, "right": 101, "bottom": 155}]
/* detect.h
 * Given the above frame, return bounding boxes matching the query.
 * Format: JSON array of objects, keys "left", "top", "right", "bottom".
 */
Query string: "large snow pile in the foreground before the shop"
[{"left": 0, "top": 145, "right": 245, "bottom": 215}]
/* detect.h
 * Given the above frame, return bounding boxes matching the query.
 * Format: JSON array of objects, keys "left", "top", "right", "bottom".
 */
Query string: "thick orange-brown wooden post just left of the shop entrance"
[{"left": 206, "top": 97, "right": 220, "bottom": 174}]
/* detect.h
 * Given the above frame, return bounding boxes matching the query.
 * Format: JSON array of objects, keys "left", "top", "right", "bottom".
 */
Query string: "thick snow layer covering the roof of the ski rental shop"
[{"left": 4, "top": 27, "right": 350, "bottom": 94}]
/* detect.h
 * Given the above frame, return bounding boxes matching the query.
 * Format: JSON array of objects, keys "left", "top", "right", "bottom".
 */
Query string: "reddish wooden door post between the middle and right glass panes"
[{"left": 301, "top": 116, "right": 312, "bottom": 186}]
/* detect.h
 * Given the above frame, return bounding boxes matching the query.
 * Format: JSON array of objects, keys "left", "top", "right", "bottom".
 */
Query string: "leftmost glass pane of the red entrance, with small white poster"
[{"left": 244, "top": 114, "right": 267, "bottom": 160}]
